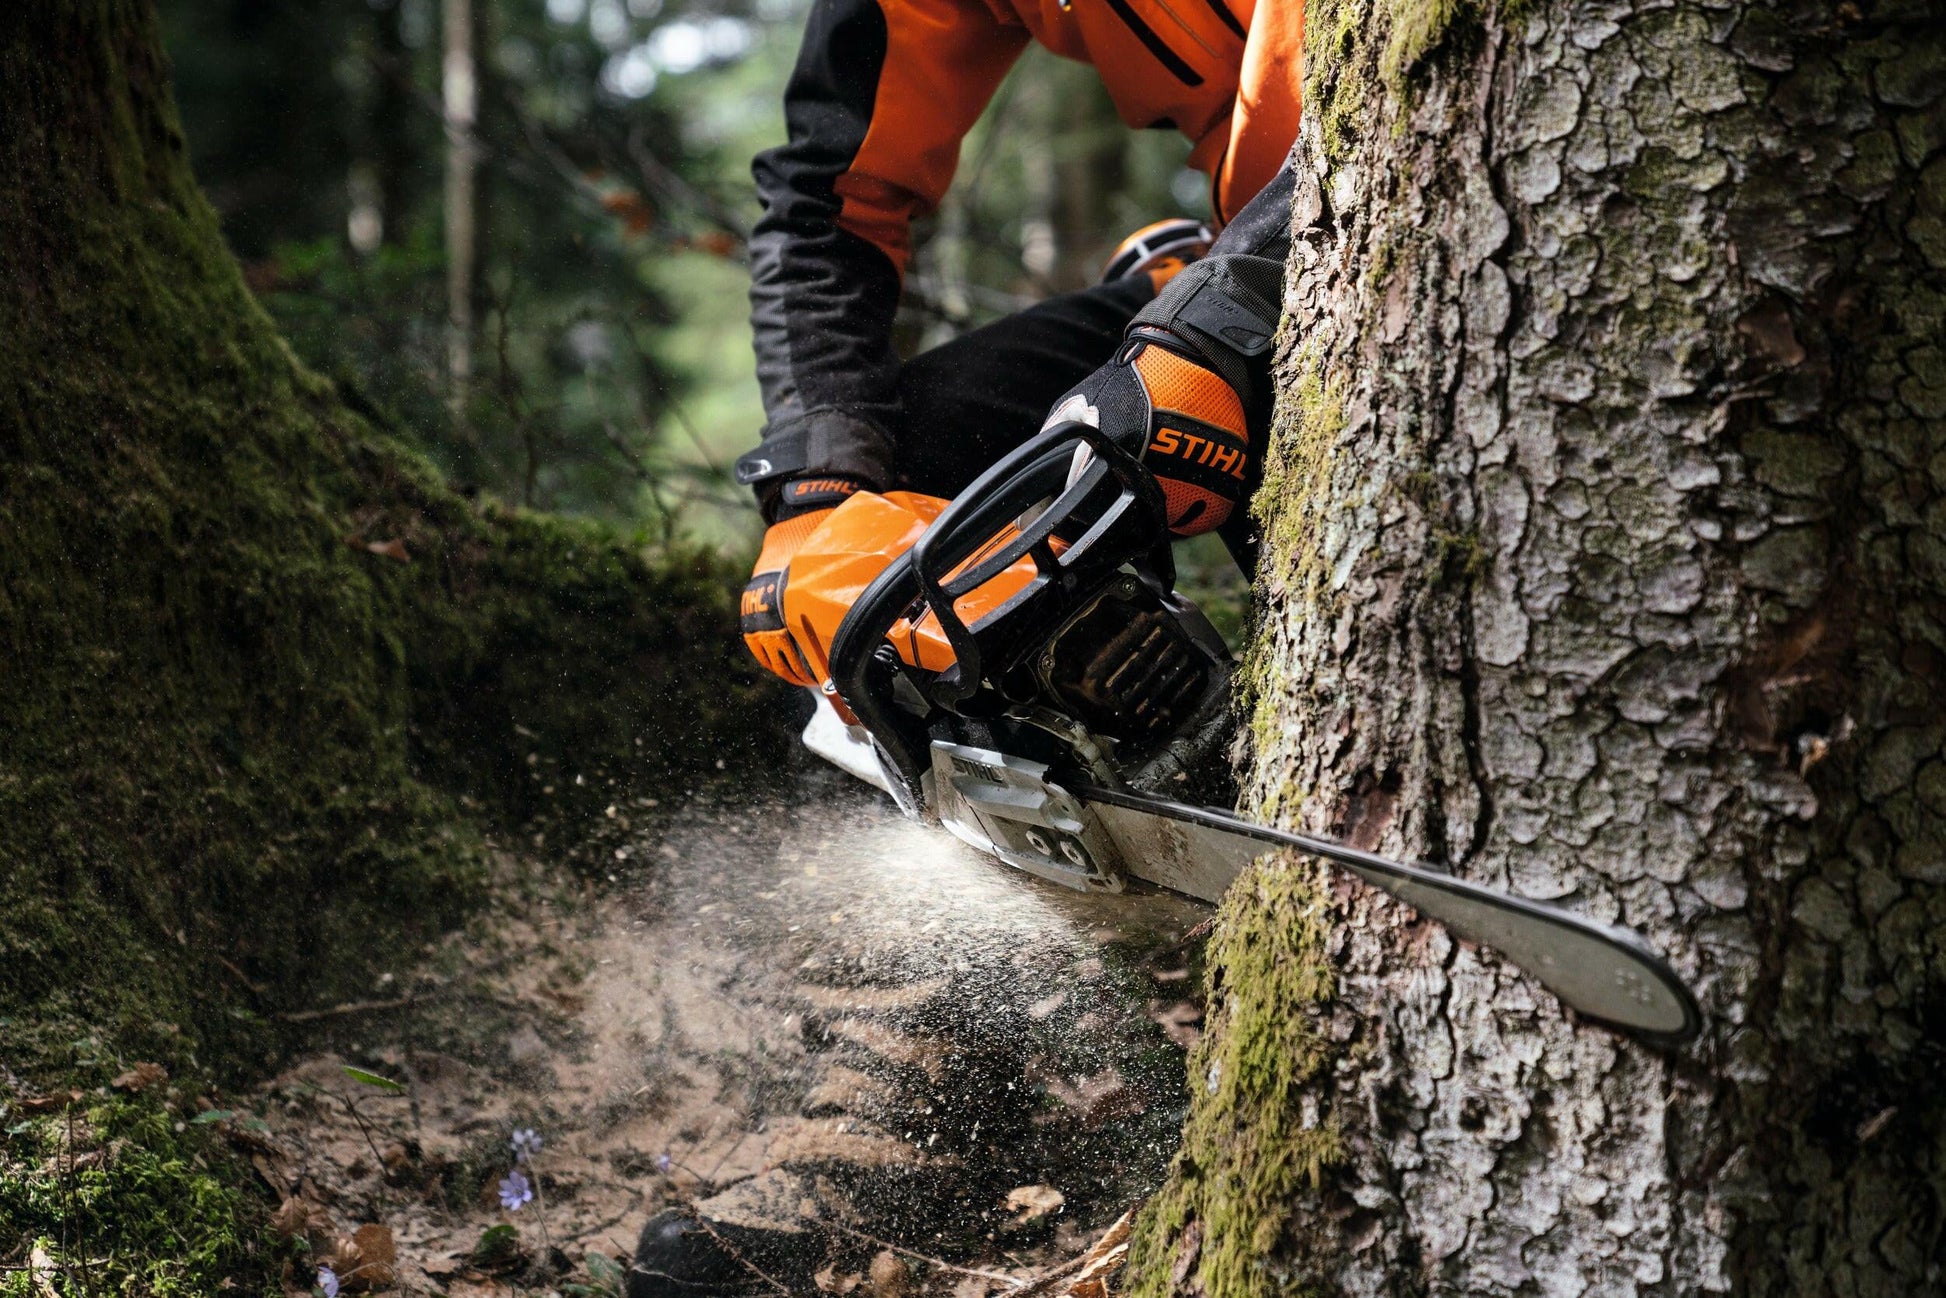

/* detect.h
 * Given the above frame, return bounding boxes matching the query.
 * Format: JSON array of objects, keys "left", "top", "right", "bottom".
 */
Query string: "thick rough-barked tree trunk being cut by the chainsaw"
[{"left": 1131, "top": 0, "right": 1946, "bottom": 1296}]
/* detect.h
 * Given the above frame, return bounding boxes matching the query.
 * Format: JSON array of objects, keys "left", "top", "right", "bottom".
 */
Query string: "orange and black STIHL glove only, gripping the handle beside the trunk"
[{"left": 1047, "top": 325, "right": 1249, "bottom": 537}]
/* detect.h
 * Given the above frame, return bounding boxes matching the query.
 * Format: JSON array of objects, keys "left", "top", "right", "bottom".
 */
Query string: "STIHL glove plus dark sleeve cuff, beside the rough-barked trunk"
[{"left": 1049, "top": 257, "right": 1282, "bottom": 537}]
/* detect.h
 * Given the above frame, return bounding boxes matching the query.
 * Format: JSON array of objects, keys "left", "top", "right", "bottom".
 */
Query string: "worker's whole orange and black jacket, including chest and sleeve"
[{"left": 738, "top": 0, "right": 1304, "bottom": 514}]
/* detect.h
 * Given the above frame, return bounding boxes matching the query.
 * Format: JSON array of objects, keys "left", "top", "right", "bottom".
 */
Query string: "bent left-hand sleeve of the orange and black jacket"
[{"left": 738, "top": 0, "right": 1027, "bottom": 504}]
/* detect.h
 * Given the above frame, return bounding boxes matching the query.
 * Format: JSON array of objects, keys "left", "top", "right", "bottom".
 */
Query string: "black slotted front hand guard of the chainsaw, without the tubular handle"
[{"left": 911, "top": 420, "right": 1168, "bottom": 704}]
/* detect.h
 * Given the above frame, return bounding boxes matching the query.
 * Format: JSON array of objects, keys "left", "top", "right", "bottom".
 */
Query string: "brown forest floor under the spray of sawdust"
[{"left": 239, "top": 780, "right": 1208, "bottom": 1298}]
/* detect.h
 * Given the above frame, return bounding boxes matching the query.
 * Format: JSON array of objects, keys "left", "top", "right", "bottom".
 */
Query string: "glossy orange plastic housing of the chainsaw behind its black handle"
[{"left": 784, "top": 490, "right": 1035, "bottom": 685}]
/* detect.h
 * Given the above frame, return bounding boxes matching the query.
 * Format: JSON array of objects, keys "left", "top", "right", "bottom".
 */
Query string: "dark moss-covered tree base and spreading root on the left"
[{"left": 0, "top": 0, "right": 780, "bottom": 1068}]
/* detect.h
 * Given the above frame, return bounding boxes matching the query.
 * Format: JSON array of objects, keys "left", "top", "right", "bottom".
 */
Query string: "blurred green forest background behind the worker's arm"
[{"left": 162, "top": 0, "right": 1208, "bottom": 549}]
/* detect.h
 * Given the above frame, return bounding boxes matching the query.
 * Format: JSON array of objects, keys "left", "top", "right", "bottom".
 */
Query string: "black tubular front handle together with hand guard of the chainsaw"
[{"left": 831, "top": 420, "right": 1173, "bottom": 792}]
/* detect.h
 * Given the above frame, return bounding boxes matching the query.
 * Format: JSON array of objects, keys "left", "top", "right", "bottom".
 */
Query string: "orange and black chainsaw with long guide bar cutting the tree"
[{"left": 784, "top": 422, "right": 1703, "bottom": 1045}]
